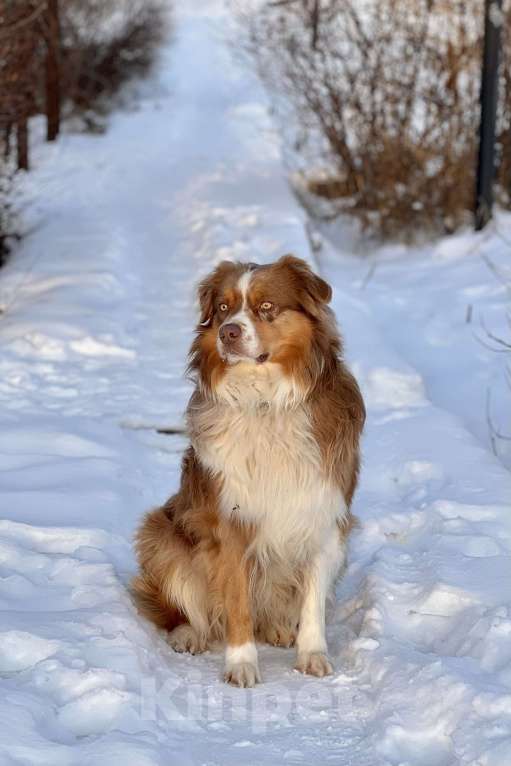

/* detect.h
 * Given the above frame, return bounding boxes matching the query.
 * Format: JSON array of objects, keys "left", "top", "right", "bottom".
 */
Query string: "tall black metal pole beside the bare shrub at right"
[{"left": 475, "top": 0, "right": 503, "bottom": 231}]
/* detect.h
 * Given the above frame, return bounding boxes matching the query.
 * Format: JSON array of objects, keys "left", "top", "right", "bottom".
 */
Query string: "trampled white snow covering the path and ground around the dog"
[{"left": 0, "top": 0, "right": 511, "bottom": 766}]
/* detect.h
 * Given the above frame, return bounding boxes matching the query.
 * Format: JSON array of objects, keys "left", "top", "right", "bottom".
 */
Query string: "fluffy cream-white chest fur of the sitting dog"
[{"left": 192, "top": 364, "right": 346, "bottom": 558}]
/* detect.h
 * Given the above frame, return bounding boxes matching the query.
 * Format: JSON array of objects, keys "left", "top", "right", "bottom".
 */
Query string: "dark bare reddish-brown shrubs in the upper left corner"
[{"left": 0, "top": 0, "right": 168, "bottom": 266}]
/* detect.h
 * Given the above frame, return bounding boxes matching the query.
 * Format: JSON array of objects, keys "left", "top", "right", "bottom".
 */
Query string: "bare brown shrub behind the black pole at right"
[{"left": 247, "top": 0, "right": 511, "bottom": 236}]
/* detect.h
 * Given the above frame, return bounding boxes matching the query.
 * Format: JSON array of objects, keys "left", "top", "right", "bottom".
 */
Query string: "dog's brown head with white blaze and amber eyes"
[{"left": 191, "top": 255, "right": 339, "bottom": 402}]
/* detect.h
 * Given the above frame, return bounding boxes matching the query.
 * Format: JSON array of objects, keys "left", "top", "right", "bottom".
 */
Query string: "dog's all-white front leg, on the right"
[{"left": 295, "top": 528, "right": 345, "bottom": 677}]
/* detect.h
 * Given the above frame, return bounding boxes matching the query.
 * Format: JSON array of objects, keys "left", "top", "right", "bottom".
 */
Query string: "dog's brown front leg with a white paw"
[{"left": 222, "top": 546, "right": 261, "bottom": 686}]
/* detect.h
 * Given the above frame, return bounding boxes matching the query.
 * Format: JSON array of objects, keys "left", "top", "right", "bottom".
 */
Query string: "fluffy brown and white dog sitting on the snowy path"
[{"left": 133, "top": 255, "right": 365, "bottom": 686}]
